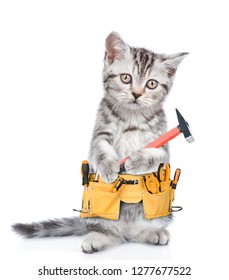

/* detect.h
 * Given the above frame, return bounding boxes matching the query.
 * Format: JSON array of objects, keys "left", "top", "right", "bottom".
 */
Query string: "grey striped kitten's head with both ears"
[{"left": 103, "top": 32, "right": 188, "bottom": 111}]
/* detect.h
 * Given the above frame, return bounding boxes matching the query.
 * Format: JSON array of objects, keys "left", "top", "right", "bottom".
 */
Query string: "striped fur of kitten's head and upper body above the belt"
[{"left": 89, "top": 32, "right": 187, "bottom": 183}]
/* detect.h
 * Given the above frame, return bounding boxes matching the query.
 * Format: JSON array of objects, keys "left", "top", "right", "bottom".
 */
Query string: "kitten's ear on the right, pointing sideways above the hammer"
[{"left": 163, "top": 53, "right": 188, "bottom": 77}]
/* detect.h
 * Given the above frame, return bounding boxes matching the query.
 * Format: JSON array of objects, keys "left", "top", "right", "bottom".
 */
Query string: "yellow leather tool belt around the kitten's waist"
[{"left": 80, "top": 164, "right": 182, "bottom": 220}]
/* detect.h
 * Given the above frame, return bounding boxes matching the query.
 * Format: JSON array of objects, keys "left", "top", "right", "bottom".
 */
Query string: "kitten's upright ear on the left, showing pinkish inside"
[{"left": 105, "top": 32, "right": 130, "bottom": 64}]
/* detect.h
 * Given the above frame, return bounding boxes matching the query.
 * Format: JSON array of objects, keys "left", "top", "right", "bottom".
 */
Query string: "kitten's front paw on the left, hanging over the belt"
[{"left": 97, "top": 161, "right": 119, "bottom": 184}]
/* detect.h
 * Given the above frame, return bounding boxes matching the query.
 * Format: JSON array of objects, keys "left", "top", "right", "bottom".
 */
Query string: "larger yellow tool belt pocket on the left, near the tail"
[{"left": 80, "top": 177, "right": 120, "bottom": 220}]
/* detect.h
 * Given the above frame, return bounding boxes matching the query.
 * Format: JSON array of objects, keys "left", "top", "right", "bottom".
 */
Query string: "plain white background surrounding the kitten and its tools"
[{"left": 0, "top": 0, "right": 229, "bottom": 280}]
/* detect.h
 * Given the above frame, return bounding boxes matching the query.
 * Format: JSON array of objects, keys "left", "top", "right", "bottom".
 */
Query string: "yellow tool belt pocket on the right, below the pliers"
[{"left": 143, "top": 180, "right": 171, "bottom": 219}]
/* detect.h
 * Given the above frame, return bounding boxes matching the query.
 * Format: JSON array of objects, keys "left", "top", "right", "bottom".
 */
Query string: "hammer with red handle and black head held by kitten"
[{"left": 119, "top": 109, "right": 194, "bottom": 172}]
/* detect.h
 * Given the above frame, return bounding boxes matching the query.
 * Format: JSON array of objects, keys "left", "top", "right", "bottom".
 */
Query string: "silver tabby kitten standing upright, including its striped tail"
[{"left": 13, "top": 32, "right": 187, "bottom": 253}]
